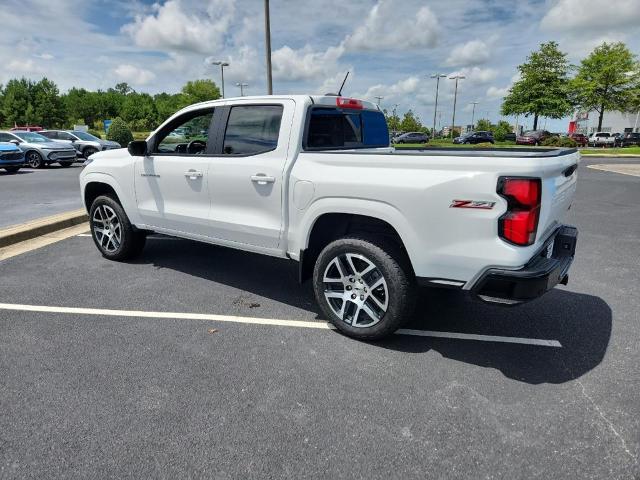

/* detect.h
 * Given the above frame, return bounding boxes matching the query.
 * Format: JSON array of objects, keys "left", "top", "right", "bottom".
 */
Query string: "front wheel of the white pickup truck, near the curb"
[{"left": 89, "top": 195, "right": 147, "bottom": 261}]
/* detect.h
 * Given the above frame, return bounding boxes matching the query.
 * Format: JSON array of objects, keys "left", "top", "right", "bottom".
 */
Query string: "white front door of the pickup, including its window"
[{"left": 134, "top": 108, "right": 213, "bottom": 236}]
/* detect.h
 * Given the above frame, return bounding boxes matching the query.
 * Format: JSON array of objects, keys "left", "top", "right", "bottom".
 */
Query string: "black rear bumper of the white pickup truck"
[{"left": 471, "top": 225, "right": 578, "bottom": 305}]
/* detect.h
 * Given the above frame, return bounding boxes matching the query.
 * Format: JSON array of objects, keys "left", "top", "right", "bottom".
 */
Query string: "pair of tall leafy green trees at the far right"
[{"left": 501, "top": 42, "right": 640, "bottom": 130}]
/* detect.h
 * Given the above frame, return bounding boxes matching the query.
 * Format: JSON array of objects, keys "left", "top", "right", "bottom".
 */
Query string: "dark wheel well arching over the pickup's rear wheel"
[{"left": 299, "top": 213, "right": 408, "bottom": 283}]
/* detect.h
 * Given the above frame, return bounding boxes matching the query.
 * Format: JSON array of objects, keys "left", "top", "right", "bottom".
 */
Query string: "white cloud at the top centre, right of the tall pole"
[{"left": 345, "top": 0, "right": 438, "bottom": 51}]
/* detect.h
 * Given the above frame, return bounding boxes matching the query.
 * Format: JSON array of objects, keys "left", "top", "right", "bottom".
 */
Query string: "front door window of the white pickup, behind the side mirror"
[{"left": 154, "top": 109, "right": 213, "bottom": 155}]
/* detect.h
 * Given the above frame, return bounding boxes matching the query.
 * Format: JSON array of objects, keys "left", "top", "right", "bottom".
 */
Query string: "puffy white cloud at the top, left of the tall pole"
[{"left": 122, "top": 0, "right": 234, "bottom": 54}]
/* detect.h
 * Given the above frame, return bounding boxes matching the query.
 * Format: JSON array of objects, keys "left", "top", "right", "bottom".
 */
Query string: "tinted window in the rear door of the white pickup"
[{"left": 222, "top": 105, "right": 282, "bottom": 155}]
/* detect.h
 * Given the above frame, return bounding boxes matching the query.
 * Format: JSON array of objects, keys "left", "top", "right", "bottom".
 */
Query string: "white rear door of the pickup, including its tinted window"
[{"left": 209, "top": 100, "right": 295, "bottom": 249}]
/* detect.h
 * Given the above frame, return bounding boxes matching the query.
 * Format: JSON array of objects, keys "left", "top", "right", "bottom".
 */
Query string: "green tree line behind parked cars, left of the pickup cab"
[{"left": 0, "top": 78, "right": 220, "bottom": 131}]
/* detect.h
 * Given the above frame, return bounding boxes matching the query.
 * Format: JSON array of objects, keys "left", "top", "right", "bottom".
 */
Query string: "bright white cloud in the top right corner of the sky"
[{"left": 540, "top": 0, "right": 640, "bottom": 33}]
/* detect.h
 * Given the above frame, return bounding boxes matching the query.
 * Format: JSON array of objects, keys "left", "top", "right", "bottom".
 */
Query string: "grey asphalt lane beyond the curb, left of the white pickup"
[{"left": 0, "top": 163, "right": 82, "bottom": 229}]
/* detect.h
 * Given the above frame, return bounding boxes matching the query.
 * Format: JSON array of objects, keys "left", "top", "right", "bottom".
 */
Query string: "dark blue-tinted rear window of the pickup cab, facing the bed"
[{"left": 305, "top": 107, "right": 389, "bottom": 150}]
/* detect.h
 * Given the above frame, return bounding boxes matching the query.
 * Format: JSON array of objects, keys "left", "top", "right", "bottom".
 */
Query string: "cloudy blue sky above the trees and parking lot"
[{"left": 0, "top": 0, "right": 640, "bottom": 131}]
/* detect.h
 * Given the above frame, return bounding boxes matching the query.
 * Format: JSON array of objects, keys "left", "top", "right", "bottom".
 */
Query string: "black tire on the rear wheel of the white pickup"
[{"left": 313, "top": 235, "right": 415, "bottom": 340}]
